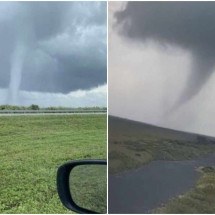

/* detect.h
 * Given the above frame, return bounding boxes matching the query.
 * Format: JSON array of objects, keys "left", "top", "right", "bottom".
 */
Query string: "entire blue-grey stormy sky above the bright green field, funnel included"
[{"left": 0, "top": 2, "right": 107, "bottom": 106}]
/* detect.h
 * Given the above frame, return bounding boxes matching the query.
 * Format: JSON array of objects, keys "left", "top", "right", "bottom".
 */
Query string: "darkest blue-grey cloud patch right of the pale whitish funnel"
[{"left": 21, "top": 50, "right": 106, "bottom": 92}]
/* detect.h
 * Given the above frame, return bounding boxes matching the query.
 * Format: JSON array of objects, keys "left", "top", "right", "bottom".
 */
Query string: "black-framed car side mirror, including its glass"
[{"left": 57, "top": 160, "right": 107, "bottom": 214}]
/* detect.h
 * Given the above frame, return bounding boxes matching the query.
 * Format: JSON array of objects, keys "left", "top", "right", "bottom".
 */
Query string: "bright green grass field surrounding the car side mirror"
[{"left": 0, "top": 115, "right": 107, "bottom": 213}]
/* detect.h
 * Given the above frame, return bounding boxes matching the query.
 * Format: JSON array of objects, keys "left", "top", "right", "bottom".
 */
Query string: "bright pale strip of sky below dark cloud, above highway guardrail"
[{"left": 0, "top": 84, "right": 107, "bottom": 107}]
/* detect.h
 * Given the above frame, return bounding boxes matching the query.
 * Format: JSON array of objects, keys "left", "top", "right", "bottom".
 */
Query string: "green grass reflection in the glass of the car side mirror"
[{"left": 70, "top": 164, "right": 107, "bottom": 213}]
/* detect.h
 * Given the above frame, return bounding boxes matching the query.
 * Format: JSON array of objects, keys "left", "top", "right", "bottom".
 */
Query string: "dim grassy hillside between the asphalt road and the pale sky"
[{"left": 108, "top": 116, "right": 215, "bottom": 174}]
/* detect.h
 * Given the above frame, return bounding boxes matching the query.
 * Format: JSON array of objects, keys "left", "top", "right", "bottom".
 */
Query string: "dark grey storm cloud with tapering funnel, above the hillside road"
[{"left": 115, "top": 2, "right": 215, "bottom": 107}]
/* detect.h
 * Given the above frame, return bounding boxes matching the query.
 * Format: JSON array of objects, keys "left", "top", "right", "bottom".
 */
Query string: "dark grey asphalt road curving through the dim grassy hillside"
[{"left": 108, "top": 154, "right": 215, "bottom": 214}]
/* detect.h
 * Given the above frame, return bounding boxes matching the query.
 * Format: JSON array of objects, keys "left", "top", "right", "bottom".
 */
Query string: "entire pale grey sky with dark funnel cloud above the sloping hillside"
[{"left": 109, "top": 2, "right": 215, "bottom": 136}]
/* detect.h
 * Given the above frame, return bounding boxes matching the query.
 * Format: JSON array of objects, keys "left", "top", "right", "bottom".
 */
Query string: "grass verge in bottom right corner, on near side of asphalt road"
[{"left": 153, "top": 167, "right": 215, "bottom": 214}]
